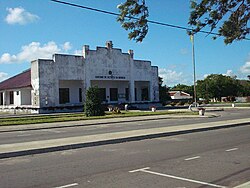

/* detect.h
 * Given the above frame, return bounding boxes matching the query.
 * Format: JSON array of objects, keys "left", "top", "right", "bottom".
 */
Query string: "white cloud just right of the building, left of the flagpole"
[{"left": 159, "top": 69, "right": 191, "bottom": 86}]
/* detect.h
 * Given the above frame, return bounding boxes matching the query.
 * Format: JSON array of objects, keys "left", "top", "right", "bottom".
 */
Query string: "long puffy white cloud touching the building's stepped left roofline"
[{"left": 0, "top": 41, "right": 71, "bottom": 64}]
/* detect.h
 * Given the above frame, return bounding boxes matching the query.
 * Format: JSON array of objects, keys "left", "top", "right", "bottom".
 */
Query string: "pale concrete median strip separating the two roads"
[{"left": 0, "top": 117, "right": 250, "bottom": 159}]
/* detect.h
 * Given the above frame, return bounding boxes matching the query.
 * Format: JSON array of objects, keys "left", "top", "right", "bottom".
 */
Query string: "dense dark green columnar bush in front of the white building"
[{"left": 84, "top": 87, "right": 105, "bottom": 116}]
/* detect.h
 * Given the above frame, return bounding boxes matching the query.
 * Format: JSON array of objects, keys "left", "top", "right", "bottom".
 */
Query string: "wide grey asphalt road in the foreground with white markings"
[{"left": 0, "top": 125, "right": 250, "bottom": 188}]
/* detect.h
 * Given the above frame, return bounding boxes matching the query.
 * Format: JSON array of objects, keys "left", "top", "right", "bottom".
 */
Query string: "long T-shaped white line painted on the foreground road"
[{"left": 129, "top": 167, "right": 226, "bottom": 188}]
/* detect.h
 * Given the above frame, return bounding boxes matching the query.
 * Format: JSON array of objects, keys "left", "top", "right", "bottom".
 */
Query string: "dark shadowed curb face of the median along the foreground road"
[{"left": 0, "top": 119, "right": 250, "bottom": 159}]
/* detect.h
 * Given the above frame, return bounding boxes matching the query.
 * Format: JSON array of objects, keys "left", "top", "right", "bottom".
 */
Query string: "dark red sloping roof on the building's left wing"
[{"left": 0, "top": 69, "right": 31, "bottom": 90}]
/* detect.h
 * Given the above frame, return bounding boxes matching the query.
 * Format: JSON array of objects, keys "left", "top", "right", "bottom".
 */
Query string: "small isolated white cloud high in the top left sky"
[{"left": 5, "top": 7, "right": 39, "bottom": 25}]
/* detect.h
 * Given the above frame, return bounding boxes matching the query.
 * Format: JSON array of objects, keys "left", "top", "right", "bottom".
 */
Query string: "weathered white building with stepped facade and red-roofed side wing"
[{"left": 0, "top": 41, "right": 159, "bottom": 113}]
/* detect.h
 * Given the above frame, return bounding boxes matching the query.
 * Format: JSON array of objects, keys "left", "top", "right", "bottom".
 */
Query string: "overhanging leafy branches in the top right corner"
[{"left": 189, "top": 0, "right": 250, "bottom": 44}]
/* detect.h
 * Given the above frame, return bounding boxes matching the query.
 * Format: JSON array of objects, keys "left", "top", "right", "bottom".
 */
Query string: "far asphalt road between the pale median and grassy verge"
[{"left": 0, "top": 109, "right": 250, "bottom": 144}]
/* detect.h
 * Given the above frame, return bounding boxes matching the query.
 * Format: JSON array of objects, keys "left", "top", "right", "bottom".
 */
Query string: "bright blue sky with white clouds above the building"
[{"left": 0, "top": 0, "right": 250, "bottom": 86}]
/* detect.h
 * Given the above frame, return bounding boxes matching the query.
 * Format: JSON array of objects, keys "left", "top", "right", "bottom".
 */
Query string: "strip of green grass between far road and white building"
[{"left": 0, "top": 111, "right": 198, "bottom": 126}]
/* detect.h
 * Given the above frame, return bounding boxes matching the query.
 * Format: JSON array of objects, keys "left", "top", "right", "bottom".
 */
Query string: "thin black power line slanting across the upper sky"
[{"left": 50, "top": 0, "right": 250, "bottom": 40}]
